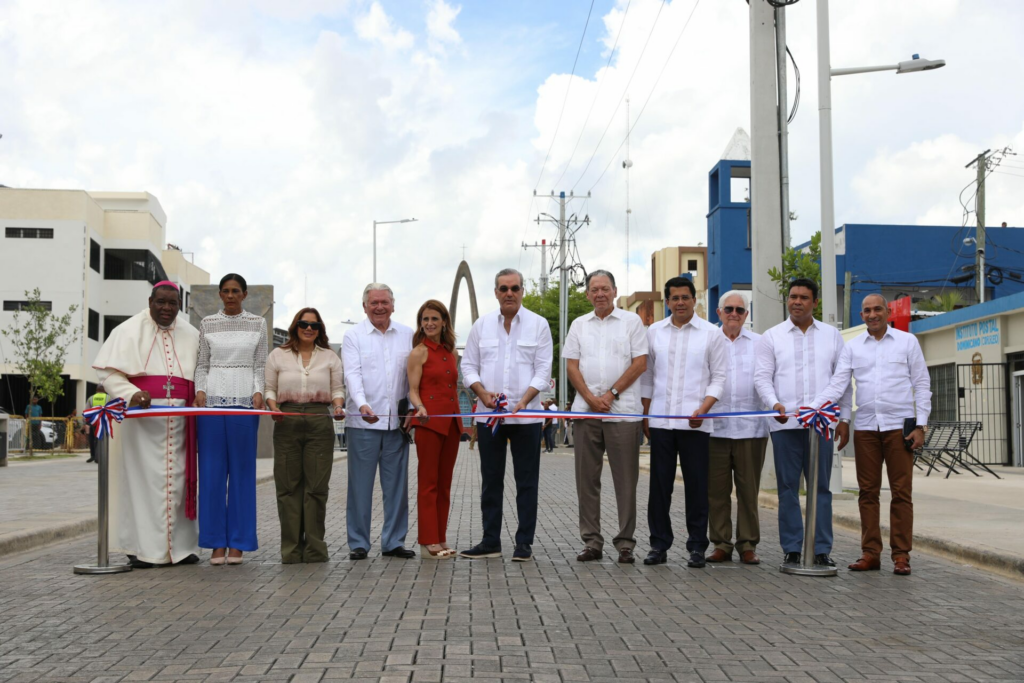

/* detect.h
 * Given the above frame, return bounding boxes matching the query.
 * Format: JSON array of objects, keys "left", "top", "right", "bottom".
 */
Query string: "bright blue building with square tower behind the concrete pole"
[{"left": 708, "top": 160, "right": 1024, "bottom": 325}]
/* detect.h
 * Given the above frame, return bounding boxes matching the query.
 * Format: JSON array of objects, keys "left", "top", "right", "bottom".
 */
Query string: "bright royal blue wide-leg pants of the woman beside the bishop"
[{"left": 196, "top": 415, "right": 259, "bottom": 552}]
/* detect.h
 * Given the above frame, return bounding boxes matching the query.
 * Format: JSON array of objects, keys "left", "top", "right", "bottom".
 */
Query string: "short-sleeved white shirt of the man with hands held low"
[{"left": 562, "top": 308, "right": 647, "bottom": 422}]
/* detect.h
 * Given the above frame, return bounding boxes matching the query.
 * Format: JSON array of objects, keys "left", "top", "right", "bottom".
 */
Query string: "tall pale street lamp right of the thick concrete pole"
[{"left": 817, "top": 0, "right": 946, "bottom": 326}]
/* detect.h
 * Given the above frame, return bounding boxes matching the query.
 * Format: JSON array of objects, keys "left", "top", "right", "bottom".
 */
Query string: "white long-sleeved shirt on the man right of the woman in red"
[{"left": 462, "top": 306, "right": 555, "bottom": 424}]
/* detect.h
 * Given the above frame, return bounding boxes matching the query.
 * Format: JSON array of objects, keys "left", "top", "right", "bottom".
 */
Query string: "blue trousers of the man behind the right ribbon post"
[{"left": 771, "top": 432, "right": 833, "bottom": 555}]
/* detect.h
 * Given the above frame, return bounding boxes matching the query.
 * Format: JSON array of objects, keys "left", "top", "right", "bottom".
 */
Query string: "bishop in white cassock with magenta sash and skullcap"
[{"left": 93, "top": 282, "right": 199, "bottom": 568}]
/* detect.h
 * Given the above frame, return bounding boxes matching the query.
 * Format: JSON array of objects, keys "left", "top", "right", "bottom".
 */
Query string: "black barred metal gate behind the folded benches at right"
[{"left": 954, "top": 362, "right": 1013, "bottom": 465}]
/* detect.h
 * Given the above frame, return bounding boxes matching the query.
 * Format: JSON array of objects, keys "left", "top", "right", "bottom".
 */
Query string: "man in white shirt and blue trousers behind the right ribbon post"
[{"left": 754, "top": 279, "right": 851, "bottom": 566}]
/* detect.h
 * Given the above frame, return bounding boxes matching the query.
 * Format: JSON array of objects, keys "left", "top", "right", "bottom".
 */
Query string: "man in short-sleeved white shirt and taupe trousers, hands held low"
[{"left": 562, "top": 270, "right": 647, "bottom": 564}]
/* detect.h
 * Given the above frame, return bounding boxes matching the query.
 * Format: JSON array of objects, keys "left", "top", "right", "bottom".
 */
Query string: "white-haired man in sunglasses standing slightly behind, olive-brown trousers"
[{"left": 708, "top": 291, "right": 768, "bottom": 564}]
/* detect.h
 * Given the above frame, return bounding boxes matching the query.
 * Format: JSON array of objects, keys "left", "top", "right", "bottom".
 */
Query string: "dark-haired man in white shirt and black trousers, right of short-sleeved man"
[{"left": 640, "top": 278, "right": 727, "bottom": 568}]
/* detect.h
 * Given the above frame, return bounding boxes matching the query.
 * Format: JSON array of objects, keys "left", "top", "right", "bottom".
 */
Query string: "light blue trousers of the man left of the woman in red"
[{"left": 345, "top": 427, "right": 409, "bottom": 552}]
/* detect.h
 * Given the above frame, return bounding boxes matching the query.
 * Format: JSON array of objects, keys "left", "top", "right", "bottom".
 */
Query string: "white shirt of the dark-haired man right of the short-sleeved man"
[{"left": 640, "top": 315, "right": 728, "bottom": 433}]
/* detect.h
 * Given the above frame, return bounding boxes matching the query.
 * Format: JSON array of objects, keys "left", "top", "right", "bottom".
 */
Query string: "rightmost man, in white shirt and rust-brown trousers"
[{"left": 815, "top": 294, "right": 932, "bottom": 575}]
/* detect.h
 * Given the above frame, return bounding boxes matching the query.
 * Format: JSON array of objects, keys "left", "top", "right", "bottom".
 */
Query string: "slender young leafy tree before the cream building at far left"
[{"left": 0, "top": 288, "right": 78, "bottom": 455}]
